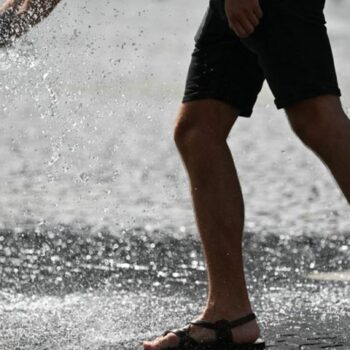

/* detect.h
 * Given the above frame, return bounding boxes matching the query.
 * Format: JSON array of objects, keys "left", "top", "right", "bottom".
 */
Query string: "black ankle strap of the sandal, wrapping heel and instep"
[{"left": 190, "top": 313, "right": 256, "bottom": 343}]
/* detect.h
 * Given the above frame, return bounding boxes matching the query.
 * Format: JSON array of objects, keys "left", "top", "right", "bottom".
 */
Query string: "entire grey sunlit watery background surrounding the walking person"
[{"left": 0, "top": 0, "right": 350, "bottom": 349}]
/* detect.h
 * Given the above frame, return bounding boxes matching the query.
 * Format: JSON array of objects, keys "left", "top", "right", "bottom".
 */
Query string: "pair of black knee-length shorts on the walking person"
[{"left": 182, "top": 0, "right": 341, "bottom": 117}]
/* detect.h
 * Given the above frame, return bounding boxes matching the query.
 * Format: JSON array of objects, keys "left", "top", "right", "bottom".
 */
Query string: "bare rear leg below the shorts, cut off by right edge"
[{"left": 286, "top": 95, "right": 350, "bottom": 204}]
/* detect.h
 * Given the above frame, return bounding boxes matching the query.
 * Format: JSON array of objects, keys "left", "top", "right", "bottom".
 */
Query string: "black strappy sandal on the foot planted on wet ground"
[{"left": 162, "top": 313, "right": 265, "bottom": 350}]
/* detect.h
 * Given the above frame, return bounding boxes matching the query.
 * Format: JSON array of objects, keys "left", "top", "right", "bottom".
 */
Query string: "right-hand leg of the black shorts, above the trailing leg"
[{"left": 242, "top": 0, "right": 340, "bottom": 108}]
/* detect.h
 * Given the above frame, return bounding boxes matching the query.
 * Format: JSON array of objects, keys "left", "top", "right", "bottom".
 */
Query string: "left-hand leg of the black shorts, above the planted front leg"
[{"left": 182, "top": 0, "right": 264, "bottom": 117}]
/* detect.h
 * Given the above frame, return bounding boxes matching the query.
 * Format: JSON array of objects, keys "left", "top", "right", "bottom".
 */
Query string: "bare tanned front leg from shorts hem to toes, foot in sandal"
[{"left": 145, "top": 99, "right": 260, "bottom": 350}]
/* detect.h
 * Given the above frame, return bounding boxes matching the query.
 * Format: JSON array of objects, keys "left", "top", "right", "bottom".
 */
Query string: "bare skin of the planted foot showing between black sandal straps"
[{"left": 143, "top": 310, "right": 260, "bottom": 350}]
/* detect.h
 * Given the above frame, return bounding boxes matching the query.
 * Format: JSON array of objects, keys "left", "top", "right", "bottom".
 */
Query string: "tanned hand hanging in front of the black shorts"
[{"left": 225, "top": 0, "right": 263, "bottom": 38}]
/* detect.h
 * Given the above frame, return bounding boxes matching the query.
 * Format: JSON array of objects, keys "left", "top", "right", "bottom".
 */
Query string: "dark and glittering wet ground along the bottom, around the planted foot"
[{"left": 0, "top": 226, "right": 350, "bottom": 350}]
